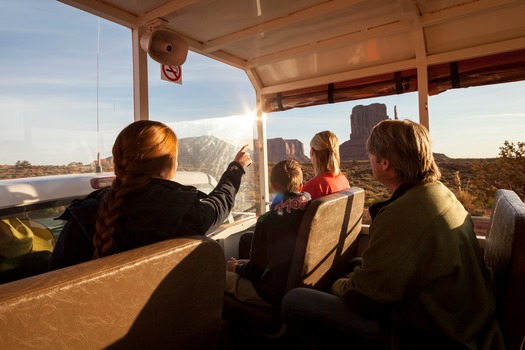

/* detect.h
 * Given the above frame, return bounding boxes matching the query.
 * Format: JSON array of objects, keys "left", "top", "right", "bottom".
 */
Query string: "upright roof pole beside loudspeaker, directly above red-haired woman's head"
[{"left": 131, "top": 27, "right": 149, "bottom": 121}]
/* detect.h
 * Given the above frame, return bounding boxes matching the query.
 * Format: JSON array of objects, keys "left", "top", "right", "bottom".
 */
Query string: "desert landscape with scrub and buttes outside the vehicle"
[{"left": 0, "top": 103, "right": 525, "bottom": 227}]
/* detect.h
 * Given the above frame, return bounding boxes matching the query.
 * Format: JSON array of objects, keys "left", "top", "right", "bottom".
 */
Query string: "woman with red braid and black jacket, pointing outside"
[{"left": 49, "top": 120, "right": 251, "bottom": 270}]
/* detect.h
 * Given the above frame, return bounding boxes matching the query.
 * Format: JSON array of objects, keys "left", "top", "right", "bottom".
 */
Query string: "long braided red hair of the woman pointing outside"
[{"left": 93, "top": 120, "right": 178, "bottom": 258}]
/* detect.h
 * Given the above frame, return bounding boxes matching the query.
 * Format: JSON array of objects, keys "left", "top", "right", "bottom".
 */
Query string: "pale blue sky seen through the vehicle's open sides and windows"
[{"left": 0, "top": 0, "right": 525, "bottom": 164}]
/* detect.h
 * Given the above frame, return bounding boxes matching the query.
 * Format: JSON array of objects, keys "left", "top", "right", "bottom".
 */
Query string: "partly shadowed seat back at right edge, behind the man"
[{"left": 484, "top": 189, "right": 525, "bottom": 350}]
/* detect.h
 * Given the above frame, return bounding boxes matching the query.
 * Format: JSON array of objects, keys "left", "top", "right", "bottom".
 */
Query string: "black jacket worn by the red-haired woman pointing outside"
[{"left": 49, "top": 162, "right": 244, "bottom": 270}]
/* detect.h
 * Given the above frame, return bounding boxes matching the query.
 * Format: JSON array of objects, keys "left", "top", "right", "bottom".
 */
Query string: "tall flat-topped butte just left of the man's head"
[{"left": 339, "top": 103, "right": 389, "bottom": 160}]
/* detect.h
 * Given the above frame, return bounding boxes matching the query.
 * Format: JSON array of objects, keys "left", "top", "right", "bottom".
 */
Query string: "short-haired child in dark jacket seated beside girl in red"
[{"left": 225, "top": 160, "right": 311, "bottom": 305}]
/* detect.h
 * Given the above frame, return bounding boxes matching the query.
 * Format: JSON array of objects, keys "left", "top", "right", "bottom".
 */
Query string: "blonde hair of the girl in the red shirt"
[{"left": 310, "top": 130, "right": 341, "bottom": 176}]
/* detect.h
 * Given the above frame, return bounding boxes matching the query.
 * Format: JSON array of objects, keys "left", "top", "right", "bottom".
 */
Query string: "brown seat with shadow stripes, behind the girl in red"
[{"left": 223, "top": 187, "right": 365, "bottom": 339}]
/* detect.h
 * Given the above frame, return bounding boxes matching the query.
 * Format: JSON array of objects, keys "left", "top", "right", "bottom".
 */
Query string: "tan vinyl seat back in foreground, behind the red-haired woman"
[{"left": 0, "top": 236, "right": 225, "bottom": 350}]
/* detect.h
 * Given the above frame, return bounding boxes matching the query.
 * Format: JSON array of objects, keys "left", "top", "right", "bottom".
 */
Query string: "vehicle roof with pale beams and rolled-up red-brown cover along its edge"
[{"left": 59, "top": 0, "right": 525, "bottom": 112}]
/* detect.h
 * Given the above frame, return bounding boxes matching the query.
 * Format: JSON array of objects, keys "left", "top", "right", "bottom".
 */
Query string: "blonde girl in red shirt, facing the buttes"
[{"left": 303, "top": 130, "right": 350, "bottom": 200}]
